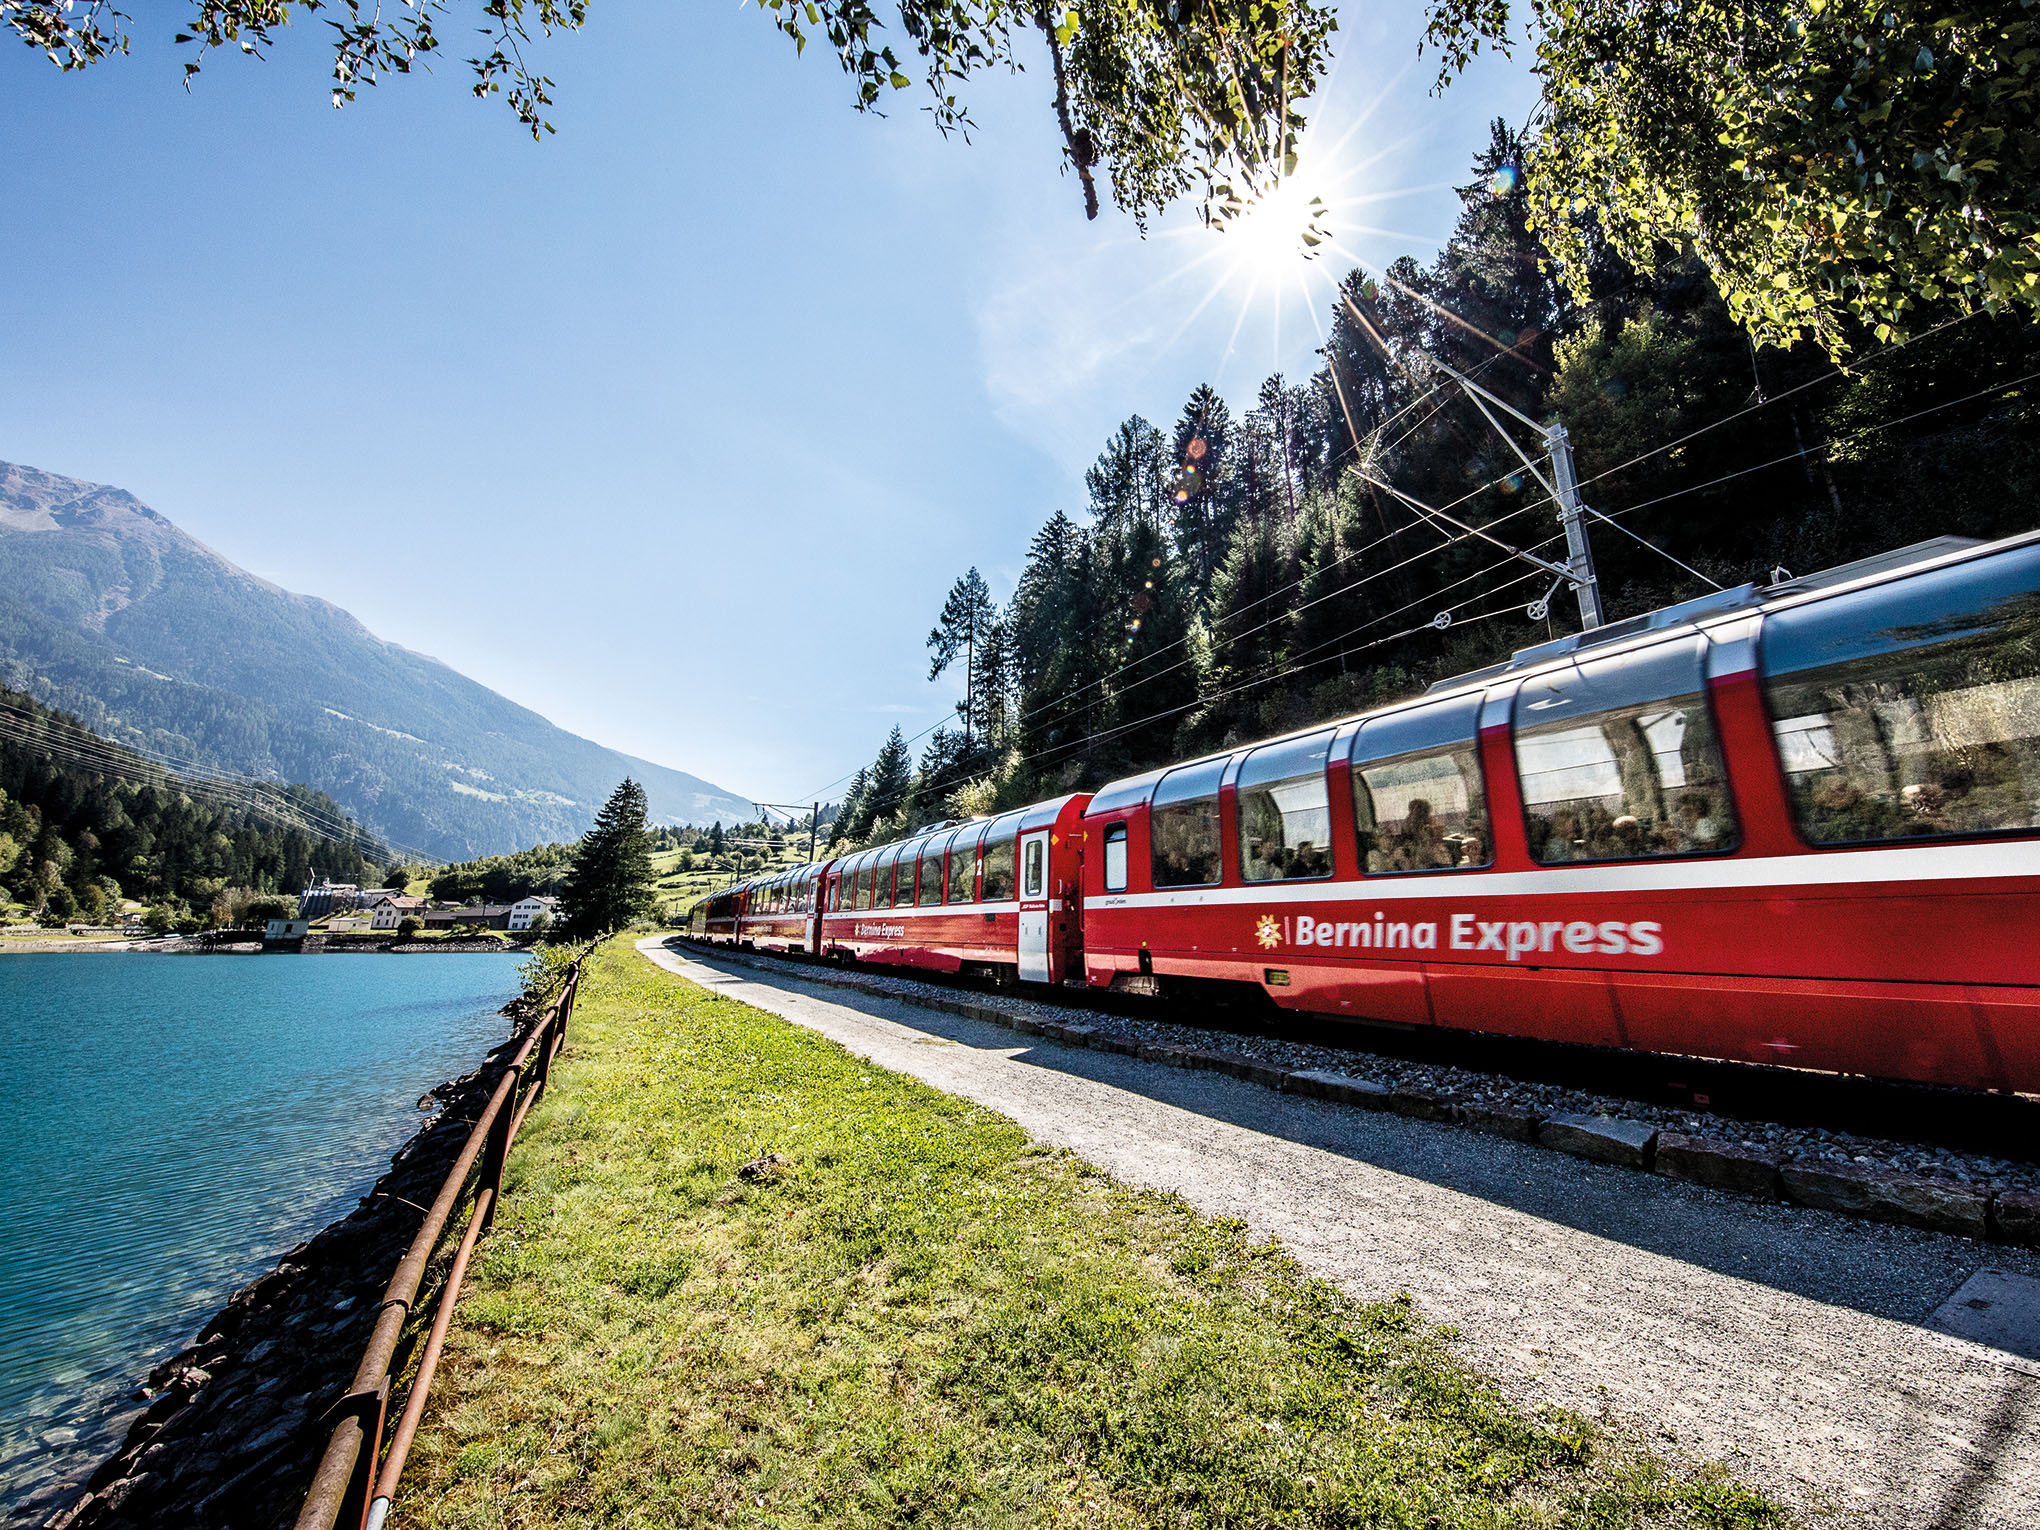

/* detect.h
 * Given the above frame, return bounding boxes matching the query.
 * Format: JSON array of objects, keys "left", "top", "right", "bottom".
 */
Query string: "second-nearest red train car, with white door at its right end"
[{"left": 818, "top": 794, "right": 1089, "bottom": 983}]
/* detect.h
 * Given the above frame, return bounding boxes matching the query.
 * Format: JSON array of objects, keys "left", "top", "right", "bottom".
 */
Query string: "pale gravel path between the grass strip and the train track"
[{"left": 639, "top": 938, "right": 2040, "bottom": 1530}]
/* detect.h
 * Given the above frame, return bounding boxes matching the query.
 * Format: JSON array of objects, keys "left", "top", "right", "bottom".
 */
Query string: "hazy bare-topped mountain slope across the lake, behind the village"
[{"left": 0, "top": 463, "right": 751, "bottom": 859}]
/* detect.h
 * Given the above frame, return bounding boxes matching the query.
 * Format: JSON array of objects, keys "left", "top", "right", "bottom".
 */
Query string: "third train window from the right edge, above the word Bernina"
[{"left": 1353, "top": 696, "right": 1493, "bottom": 873}]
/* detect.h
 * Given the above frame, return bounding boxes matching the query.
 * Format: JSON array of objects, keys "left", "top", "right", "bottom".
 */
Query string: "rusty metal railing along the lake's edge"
[{"left": 298, "top": 963, "right": 581, "bottom": 1530}]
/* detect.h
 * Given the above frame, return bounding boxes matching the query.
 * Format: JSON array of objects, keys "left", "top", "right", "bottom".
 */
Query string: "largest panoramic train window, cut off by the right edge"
[{"left": 1763, "top": 547, "right": 2040, "bottom": 845}]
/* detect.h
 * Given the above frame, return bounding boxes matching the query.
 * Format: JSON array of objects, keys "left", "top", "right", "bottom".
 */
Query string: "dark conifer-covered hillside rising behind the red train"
[{"left": 836, "top": 122, "right": 2040, "bottom": 843}]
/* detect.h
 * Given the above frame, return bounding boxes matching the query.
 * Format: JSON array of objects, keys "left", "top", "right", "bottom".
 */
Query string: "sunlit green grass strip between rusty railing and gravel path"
[{"left": 396, "top": 940, "right": 1785, "bottom": 1530}]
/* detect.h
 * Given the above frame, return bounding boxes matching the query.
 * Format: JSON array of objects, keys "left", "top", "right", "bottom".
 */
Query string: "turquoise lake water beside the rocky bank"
[{"left": 0, "top": 953, "right": 518, "bottom": 1522}]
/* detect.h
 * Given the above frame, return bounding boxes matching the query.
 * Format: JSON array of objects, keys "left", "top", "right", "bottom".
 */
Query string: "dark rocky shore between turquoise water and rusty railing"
[{"left": 41, "top": 1000, "right": 534, "bottom": 1530}]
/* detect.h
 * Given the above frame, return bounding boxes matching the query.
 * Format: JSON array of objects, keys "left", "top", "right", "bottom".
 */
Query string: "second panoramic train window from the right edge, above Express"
[{"left": 1516, "top": 639, "right": 1736, "bottom": 865}]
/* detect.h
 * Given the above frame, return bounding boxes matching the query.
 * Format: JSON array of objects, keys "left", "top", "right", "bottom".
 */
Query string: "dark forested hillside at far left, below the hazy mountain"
[{"left": 0, "top": 690, "right": 388, "bottom": 928}]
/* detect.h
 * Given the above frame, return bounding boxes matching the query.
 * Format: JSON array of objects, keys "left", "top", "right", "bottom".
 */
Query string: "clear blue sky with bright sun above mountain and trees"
[{"left": 0, "top": 0, "right": 1534, "bottom": 802}]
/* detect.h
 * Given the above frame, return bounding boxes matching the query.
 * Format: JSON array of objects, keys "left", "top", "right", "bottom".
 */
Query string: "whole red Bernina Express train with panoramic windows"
[{"left": 690, "top": 532, "right": 2040, "bottom": 1093}]
